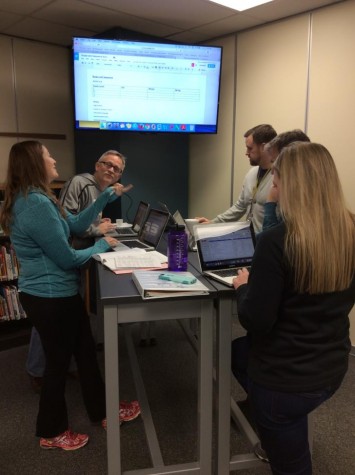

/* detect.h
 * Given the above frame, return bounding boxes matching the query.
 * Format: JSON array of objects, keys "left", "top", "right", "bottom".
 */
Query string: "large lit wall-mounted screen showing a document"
[{"left": 73, "top": 37, "right": 222, "bottom": 134}]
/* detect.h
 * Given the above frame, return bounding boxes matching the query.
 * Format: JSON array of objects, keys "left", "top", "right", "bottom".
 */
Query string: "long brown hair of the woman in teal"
[{"left": 0, "top": 140, "right": 57, "bottom": 233}]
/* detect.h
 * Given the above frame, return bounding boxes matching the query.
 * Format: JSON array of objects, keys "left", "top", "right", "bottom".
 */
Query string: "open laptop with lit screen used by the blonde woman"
[{"left": 195, "top": 221, "right": 255, "bottom": 287}]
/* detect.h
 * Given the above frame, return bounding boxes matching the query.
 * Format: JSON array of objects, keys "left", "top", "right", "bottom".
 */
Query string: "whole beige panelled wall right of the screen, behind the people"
[{"left": 189, "top": 0, "right": 355, "bottom": 345}]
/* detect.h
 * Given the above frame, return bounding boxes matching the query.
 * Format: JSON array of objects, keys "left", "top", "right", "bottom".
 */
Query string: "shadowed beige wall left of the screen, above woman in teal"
[{"left": 0, "top": 36, "right": 74, "bottom": 183}]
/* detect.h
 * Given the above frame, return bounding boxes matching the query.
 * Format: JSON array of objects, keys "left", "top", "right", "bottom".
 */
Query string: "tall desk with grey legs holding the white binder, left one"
[{"left": 97, "top": 264, "right": 217, "bottom": 475}]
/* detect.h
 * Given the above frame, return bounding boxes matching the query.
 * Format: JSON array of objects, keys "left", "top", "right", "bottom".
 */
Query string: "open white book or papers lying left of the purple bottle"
[{"left": 93, "top": 249, "right": 168, "bottom": 274}]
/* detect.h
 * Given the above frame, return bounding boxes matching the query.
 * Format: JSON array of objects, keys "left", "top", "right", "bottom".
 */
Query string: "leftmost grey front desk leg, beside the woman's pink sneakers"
[{"left": 104, "top": 305, "right": 121, "bottom": 475}]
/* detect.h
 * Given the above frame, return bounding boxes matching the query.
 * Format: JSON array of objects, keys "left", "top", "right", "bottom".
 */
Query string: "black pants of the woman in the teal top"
[{"left": 20, "top": 292, "right": 106, "bottom": 437}]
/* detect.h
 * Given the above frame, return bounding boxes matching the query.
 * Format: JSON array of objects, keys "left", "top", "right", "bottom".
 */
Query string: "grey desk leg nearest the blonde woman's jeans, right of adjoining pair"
[{"left": 216, "top": 297, "right": 232, "bottom": 475}]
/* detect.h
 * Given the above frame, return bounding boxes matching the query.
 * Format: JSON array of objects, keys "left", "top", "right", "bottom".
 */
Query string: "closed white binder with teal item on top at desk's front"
[{"left": 132, "top": 270, "right": 209, "bottom": 300}]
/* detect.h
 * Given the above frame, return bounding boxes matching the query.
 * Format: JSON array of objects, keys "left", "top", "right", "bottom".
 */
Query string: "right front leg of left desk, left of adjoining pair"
[{"left": 198, "top": 300, "right": 213, "bottom": 475}]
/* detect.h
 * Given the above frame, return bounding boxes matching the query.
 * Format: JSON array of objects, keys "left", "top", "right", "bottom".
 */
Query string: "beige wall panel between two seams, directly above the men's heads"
[{"left": 233, "top": 15, "right": 309, "bottom": 200}]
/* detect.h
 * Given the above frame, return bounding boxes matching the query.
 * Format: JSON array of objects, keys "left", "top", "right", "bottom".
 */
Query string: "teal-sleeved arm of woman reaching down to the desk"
[{"left": 21, "top": 198, "right": 110, "bottom": 269}]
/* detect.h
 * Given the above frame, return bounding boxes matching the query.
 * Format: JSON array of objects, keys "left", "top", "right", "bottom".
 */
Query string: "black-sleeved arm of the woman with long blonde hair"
[{"left": 236, "top": 224, "right": 285, "bottom": 333}]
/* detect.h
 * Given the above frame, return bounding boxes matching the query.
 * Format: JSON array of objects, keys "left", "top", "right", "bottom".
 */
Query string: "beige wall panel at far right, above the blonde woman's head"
[{"left": 309, "top": 1, "right": 355, "bottom": 345}]
